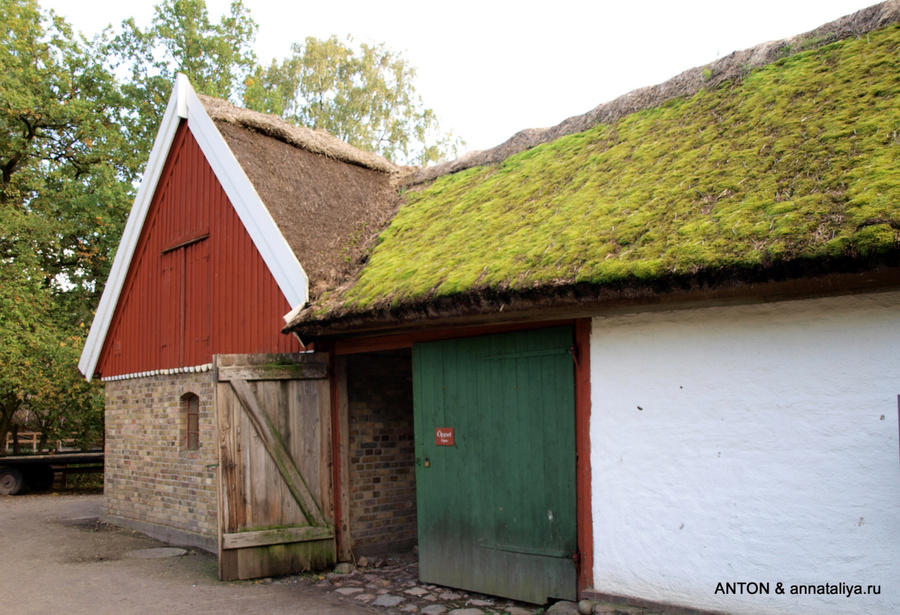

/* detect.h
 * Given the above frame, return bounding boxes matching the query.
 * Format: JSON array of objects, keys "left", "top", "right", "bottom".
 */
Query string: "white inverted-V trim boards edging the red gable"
[{"left": 78, "top": 74, "right": 309, "bottom": 380}]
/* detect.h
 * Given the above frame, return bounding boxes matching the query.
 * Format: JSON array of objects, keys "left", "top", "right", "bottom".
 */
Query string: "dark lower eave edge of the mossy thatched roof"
[{"left": 282, "top": 250, "right": 900, "bottom": 339}]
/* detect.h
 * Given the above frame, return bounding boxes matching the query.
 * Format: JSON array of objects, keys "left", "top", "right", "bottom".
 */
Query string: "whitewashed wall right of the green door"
[{"left": 591, "top": 293, "right": 900, "bottom": 615}]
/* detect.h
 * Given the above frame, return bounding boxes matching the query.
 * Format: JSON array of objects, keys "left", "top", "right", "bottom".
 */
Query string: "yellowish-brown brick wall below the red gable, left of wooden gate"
[{"left": 104, "top": 371, "right": 217, "bottom": 548}]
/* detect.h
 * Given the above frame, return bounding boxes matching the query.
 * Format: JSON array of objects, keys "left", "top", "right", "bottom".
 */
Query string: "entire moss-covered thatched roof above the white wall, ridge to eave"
[{"left": 288, "top": 0, "right": 900, "bottom": 337}]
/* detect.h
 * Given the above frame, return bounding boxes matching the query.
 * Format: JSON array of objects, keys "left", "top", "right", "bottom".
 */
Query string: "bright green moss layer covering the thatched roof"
[{"left": 332, "top": 26, "right": 900, "bottom": 309}]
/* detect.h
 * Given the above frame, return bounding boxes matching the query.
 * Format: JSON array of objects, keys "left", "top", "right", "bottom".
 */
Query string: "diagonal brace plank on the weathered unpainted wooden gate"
[{"left": 230, "top": 380, "right": 328, "bottom": 527}]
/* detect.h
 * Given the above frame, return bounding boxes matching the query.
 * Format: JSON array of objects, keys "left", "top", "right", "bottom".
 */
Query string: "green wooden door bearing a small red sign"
[{"left": 413, "top": 327, "right": 576, "bottom": 604}]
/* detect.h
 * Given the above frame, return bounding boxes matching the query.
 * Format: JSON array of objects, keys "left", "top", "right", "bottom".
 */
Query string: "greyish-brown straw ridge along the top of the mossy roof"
[{"left": 406, "top": 0, "right": 900, "bottom": 186}]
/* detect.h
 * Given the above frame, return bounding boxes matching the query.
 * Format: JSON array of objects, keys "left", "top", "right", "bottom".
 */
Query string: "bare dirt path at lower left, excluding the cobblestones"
[{"left": 0, "top": 495, "right": 373, "bottom": 615}]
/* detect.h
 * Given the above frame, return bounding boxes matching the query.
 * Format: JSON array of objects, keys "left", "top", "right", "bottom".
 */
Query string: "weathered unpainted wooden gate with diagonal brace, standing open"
[{"left": 216, "top": 354, "right": 335, "bottom": 581}]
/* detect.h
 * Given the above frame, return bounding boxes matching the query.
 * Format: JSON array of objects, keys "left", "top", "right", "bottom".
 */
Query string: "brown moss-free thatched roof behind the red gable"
[{"left": 199, "top": 96, "right": 407, "bottom": 298}]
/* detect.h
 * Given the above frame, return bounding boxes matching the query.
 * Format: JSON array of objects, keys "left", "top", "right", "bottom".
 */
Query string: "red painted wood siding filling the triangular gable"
[{"left": 98, "top": 123, "right": 301, "bottom": 377}]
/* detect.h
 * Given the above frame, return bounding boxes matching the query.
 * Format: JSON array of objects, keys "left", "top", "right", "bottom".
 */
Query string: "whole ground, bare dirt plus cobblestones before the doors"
[{"left": 0, "top": 493, "right": 665, "bottom": 615}]
